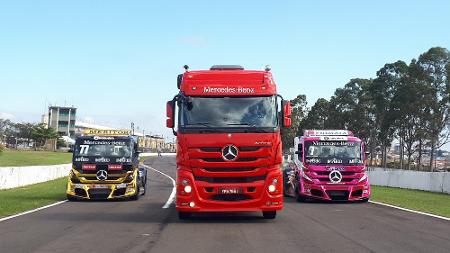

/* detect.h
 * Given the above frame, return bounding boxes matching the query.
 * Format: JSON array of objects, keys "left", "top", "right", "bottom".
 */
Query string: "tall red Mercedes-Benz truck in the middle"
[{"left": 166, "top": 65, "right": 291, "bottom": 219}]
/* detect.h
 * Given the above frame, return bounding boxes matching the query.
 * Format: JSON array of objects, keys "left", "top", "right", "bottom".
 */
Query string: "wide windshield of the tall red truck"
[{"left": 180, "top": 96, "right": 277, "bottom": 128}]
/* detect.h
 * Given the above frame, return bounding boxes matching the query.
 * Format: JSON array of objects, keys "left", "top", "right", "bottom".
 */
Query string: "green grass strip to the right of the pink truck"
[{"left": 370, "top": 185, "right": 450, "bottom": 218}]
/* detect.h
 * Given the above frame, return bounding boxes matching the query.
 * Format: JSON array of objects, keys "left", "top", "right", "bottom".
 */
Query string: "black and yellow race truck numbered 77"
[{"left": 67, "top": 130, "right": 147, "bottom": 201}]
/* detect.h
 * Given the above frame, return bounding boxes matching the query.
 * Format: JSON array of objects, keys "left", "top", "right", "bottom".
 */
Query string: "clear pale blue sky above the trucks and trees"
[{"left": 0, "top": 1, "right": 450, "bottom": 138}]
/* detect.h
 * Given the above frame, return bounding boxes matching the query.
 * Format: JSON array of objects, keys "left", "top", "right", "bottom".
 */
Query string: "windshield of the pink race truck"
[{"left": 305, "top": 141, "right": 363, "bottom": 165}]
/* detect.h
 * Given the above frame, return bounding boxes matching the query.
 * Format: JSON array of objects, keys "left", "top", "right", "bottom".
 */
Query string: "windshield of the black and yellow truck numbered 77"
[{"left": 74, "top": 141, "right": 132, "bottom": 157}]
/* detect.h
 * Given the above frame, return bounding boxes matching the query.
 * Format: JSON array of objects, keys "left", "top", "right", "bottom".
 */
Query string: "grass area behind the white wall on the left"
[{"left": 0, "top": 150, "right": 72, "bottom": 167}]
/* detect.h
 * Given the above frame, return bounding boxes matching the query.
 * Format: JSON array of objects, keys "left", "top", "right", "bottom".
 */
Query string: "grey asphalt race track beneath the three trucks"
[{"left": 0, "top": 156, "right": 450, "bottom": 253}]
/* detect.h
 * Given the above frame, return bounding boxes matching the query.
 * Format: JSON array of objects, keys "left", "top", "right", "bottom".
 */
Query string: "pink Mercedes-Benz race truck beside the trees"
[{"left": 283, "top": 130, "right": 370, "bottom": 202}]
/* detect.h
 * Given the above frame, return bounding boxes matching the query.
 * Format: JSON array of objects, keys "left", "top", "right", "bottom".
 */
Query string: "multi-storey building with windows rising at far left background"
[{"left": 48, "top": 106, "right": 77, "bottom": 137}]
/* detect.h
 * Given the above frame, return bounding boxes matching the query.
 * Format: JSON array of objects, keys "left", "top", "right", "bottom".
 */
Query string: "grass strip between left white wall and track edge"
[{"left": 0, "top": 177, "right": 67, "bottom": 217}]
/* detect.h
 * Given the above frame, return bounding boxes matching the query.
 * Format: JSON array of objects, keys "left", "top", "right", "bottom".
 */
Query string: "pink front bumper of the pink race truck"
[{"left": 300, "top": 182, "right": 370, "bottom": 201}]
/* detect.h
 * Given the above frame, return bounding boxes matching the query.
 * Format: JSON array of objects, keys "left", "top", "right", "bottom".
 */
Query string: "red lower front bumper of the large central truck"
[{"left": 176, "top": 170, "right": 283, "bottom": 212}]
